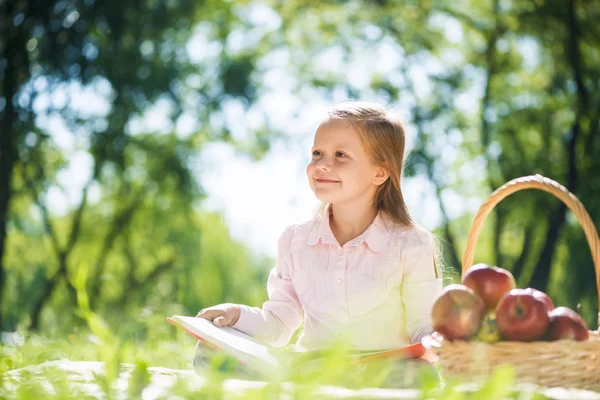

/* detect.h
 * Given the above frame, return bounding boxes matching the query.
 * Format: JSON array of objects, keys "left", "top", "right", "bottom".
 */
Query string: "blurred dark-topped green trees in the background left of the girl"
[{"left": 0, "top": 0, "right": 268, "bottom": 329}]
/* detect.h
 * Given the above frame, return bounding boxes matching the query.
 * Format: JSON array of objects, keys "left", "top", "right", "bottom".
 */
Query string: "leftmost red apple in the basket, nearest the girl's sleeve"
[{"left": 431, "top": 284, "right": 485, "bottom": 340}]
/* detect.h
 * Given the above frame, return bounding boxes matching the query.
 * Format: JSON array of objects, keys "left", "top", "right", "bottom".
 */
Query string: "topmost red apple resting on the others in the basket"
[{"left": 462, "top": 264, "right": 517, "bottom": 310}]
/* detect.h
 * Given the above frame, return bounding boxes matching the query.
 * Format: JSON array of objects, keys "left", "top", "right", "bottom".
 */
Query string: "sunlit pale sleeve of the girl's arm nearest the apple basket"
[{"left": 402, "top": 234, "right": 442, "bottom": 343}]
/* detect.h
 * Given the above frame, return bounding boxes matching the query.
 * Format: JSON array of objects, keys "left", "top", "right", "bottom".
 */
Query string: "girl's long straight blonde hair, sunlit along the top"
[{"left": 327, "top": 101, "right": 416, "bottom": 227}]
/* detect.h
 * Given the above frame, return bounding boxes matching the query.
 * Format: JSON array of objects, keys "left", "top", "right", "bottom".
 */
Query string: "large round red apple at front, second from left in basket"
[{"left": 496, "top": 289, "right": 550, "bottom": 342}]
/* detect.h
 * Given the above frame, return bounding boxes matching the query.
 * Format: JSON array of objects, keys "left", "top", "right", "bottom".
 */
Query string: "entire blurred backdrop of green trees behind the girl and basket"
[{"left": 0, "top": 0, "right": 600, "bottom": 336}]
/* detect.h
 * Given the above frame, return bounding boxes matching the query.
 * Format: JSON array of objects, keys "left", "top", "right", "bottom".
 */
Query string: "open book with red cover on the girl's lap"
[{"left": 167, "top": 315, "right": 427, "bottom": 376}]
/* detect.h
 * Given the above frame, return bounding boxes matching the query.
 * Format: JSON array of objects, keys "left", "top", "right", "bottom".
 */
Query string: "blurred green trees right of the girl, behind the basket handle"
[{"left": 272, "top": 0, "right": 600, "bottom": 323}]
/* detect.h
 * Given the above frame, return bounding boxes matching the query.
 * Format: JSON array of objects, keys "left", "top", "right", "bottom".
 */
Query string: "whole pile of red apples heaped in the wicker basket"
[{"left": 431, "top": 264, "right": 589, "bottom": 343}]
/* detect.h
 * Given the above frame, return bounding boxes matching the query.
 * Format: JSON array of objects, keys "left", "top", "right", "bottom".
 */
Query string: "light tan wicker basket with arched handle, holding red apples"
[{"left": 427, "top": 175, "right": 600, "bottom": 391}]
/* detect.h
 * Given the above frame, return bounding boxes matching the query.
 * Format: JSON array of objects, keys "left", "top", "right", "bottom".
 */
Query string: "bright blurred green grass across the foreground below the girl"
[{"left": 0, "top": 282, "right": 572, "bottom": 400}]
